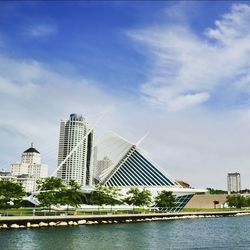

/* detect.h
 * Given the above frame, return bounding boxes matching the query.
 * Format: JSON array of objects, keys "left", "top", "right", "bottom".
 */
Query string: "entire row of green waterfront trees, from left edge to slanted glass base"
[{"left": 0, "top": 177, "right": 176, "bottom": 209}]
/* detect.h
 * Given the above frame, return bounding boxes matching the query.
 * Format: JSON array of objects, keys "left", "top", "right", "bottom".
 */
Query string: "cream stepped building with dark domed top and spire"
[{"left": 11, "top": 143, "right": 48, "bottom": 192}]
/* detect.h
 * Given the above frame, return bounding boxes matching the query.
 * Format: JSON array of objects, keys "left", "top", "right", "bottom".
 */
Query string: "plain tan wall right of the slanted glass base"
[{"left": 185, "top": 194, "right": 227, "bottom": 208}]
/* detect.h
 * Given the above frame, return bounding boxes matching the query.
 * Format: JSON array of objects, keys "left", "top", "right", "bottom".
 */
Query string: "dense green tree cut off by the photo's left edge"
[{"left": 0, "top": 180, "right": 25, "bottom": 209}]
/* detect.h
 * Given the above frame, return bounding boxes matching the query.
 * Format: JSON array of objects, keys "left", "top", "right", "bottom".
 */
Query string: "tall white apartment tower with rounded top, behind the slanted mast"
[{"left": 57, "top": 114, "right": 95, "bottom": 187}]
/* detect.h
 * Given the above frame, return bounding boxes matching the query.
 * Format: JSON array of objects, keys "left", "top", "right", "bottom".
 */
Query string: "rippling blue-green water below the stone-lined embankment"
[{"left": 0, "top": 217, "right": 250, "bottom": 250}]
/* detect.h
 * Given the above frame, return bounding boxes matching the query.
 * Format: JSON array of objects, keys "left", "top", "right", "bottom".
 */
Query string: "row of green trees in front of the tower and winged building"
[{"left": 36, "top": 177, "right": 175, "bottom": 210}]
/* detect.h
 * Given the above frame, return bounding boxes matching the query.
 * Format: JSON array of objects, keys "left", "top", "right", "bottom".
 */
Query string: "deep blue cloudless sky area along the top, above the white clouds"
[{"left": 0, "top": 1, "right": 234, "bottom": 94}]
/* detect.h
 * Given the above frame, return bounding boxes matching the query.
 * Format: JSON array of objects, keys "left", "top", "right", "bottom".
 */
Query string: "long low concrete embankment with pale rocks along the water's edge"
[{"left": 0, "top": 211, "right": 250, "bottom": 229}]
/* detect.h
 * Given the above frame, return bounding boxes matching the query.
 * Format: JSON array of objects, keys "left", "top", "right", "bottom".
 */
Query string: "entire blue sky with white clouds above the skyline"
[{"left": 0, "top": 1, "right": 250, "bottom": 189}]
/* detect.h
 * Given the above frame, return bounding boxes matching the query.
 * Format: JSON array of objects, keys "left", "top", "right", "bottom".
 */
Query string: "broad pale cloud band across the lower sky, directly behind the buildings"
[{"left": 0, "top": 52, "right": 250, "bottom": 188}]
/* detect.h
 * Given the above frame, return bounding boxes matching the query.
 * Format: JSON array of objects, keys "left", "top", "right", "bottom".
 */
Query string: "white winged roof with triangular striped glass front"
[{"left": 95, "top": 132, "right": 180, "bottom": 187}]
